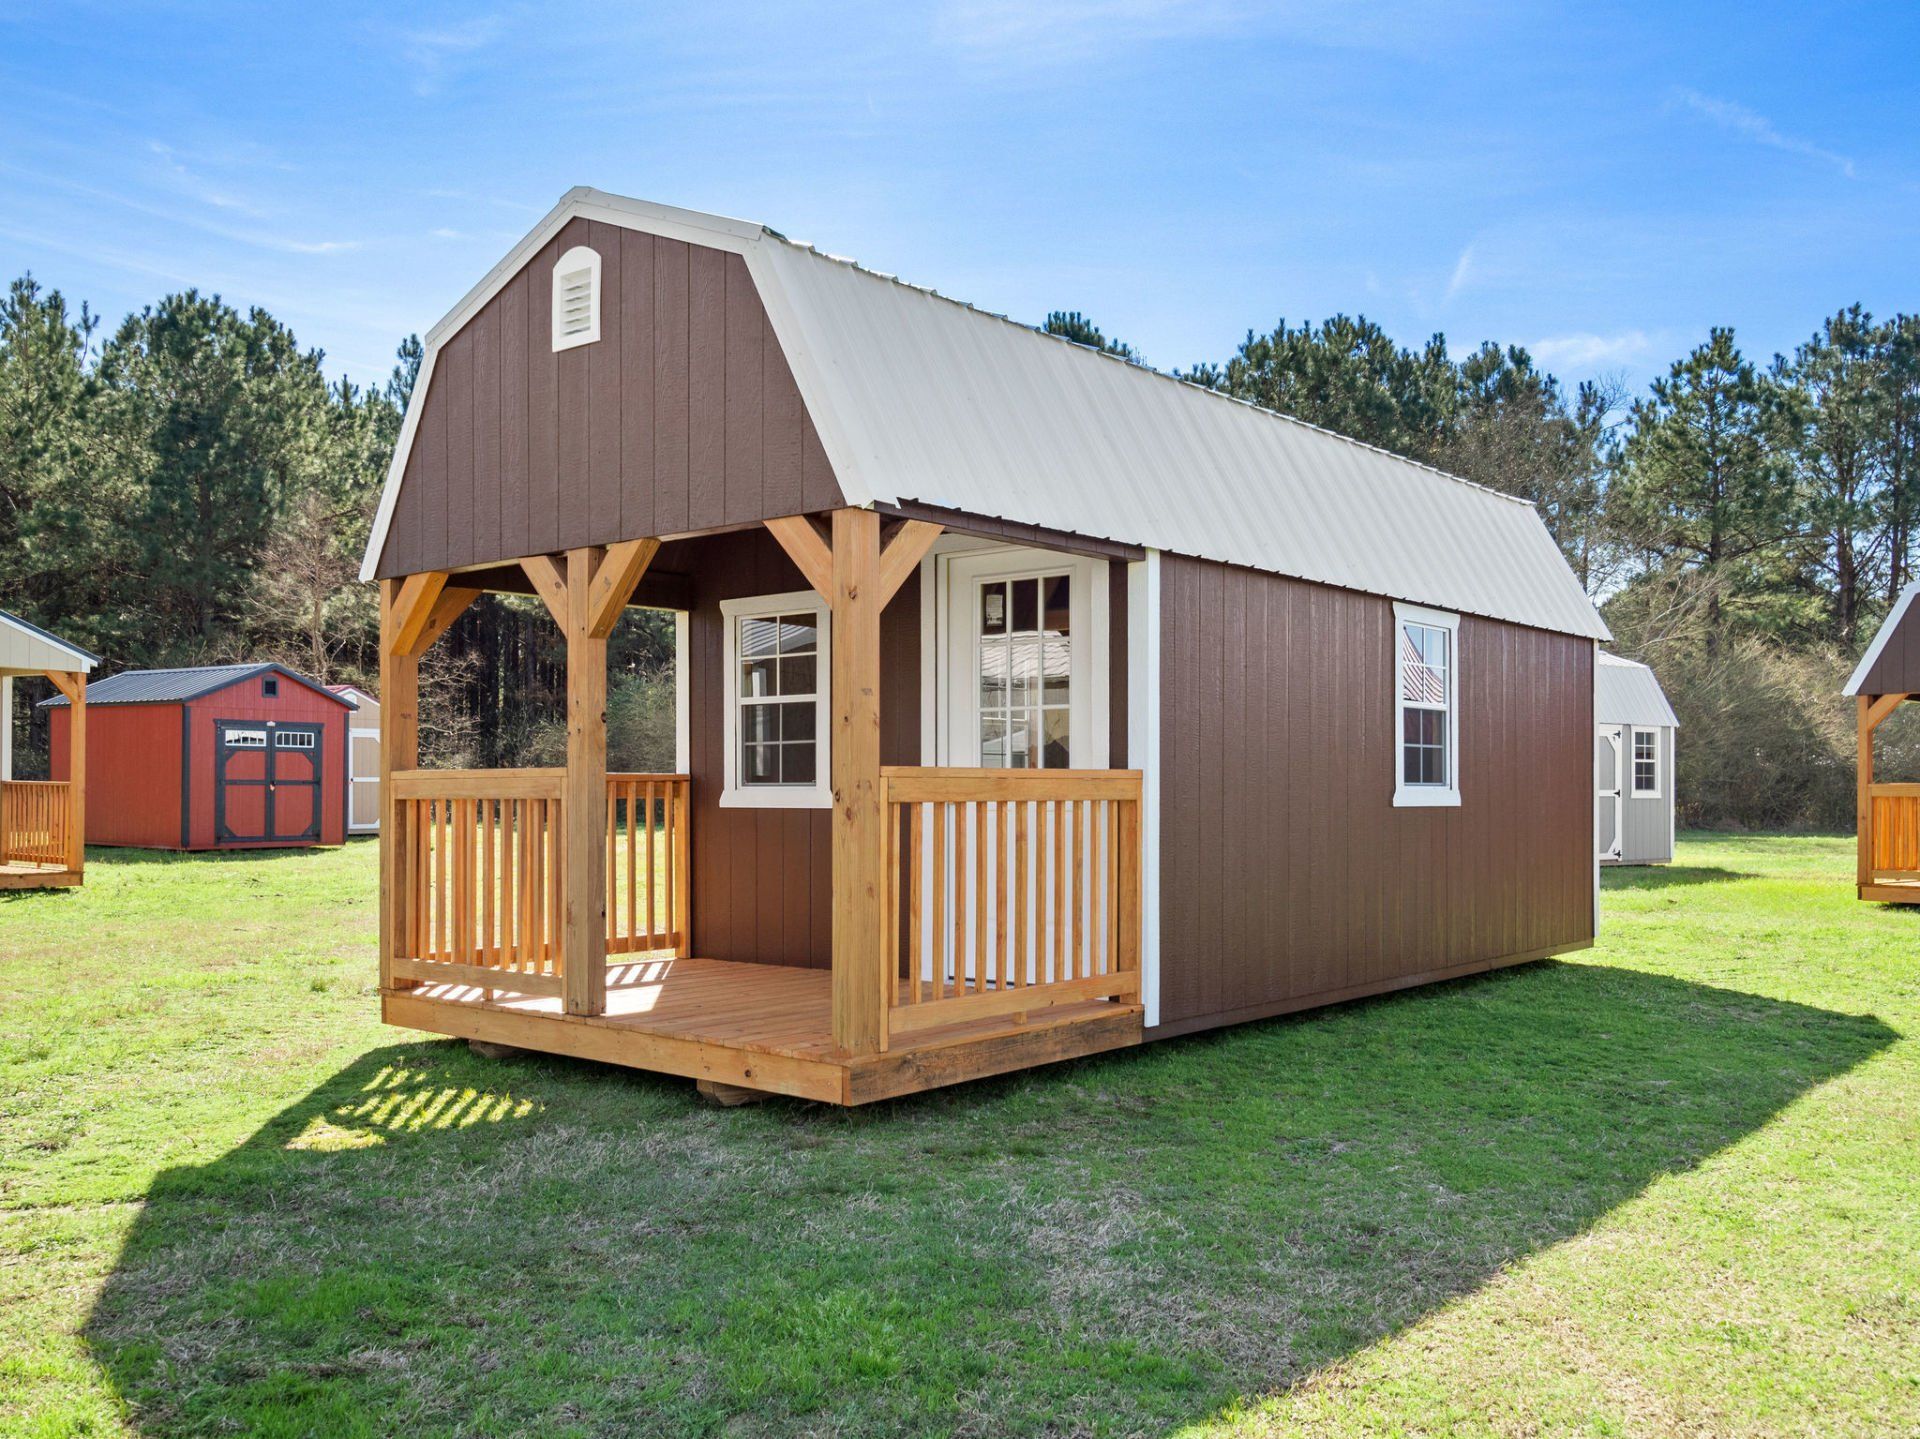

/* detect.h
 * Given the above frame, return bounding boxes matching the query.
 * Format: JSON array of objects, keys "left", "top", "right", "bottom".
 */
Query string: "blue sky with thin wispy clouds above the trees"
[{"left": 0, "top": 0, "right": 1920, "bottom": 384}]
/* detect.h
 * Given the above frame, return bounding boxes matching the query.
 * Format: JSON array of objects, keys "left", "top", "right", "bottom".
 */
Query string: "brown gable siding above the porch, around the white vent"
[{"left": 378, "top": 219, "right": 843, "bottom": 576}]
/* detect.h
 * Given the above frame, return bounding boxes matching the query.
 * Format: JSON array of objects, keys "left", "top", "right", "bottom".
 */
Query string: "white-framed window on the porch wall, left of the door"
[{"left": 720, "top": 590, "right": 833, "bottom": 809}]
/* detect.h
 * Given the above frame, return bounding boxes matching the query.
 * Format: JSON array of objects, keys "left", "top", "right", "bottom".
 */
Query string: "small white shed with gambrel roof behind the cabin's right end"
[{"left": 1594, "top": 649, "right": 1680, "bottom": 865}]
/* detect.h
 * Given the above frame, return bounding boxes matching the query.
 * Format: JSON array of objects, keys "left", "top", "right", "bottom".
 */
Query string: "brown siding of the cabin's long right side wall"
[{"left": 1160, "top": 555, "right": 1594, "bottom": 1028}]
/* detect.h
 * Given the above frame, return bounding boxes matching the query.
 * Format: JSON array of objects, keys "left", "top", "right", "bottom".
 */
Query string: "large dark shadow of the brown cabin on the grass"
[{"left": 86, "top": 964, "right": 1895, "bottom": 1435}]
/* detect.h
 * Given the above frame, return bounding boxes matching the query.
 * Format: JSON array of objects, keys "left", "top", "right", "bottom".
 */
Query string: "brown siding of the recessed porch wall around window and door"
[{"left": 675, "top": 528, "right": 920, "bottom": 968}]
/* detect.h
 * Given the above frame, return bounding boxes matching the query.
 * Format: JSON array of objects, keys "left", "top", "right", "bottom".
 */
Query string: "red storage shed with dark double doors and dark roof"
[{"left": 44, "top": 665, "right": 353, "bottom": 849}]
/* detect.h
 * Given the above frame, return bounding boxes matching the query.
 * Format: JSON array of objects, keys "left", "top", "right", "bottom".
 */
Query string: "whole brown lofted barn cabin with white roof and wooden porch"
[{"left": 365, "top": 188, "right": 1607, "bottom": 1105}]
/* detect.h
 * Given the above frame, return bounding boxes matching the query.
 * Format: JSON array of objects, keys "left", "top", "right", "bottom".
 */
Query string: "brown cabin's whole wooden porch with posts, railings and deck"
[{"left": 380, "top": 511, "right": 1142, "bottom": 1105}]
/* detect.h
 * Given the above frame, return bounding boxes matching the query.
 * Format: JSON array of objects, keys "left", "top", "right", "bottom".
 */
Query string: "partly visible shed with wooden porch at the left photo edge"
[{"left": 0, "top": 609, "right": 100, "bottom": 890}]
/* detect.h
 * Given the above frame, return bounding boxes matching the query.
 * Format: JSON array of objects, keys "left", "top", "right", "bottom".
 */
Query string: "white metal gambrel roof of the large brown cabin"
[{"left": 363, "top": 188, "right": 1609, "bottom": 640}]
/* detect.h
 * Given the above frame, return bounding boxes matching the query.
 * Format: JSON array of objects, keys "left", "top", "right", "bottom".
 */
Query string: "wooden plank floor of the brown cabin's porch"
[{"left": 382, "top": 957, "right": 1140, "bottom": 1105}]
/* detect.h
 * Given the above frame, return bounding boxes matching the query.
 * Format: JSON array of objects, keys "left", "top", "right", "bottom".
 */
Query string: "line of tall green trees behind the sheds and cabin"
[{"left": 0, "top": 277, "right": 1920, "bottom": 826}]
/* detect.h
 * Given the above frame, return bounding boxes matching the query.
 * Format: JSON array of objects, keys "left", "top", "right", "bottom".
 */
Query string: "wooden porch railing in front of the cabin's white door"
[{"left": 881, "top": 768, "right": 1140, "bottom": 1034}]
